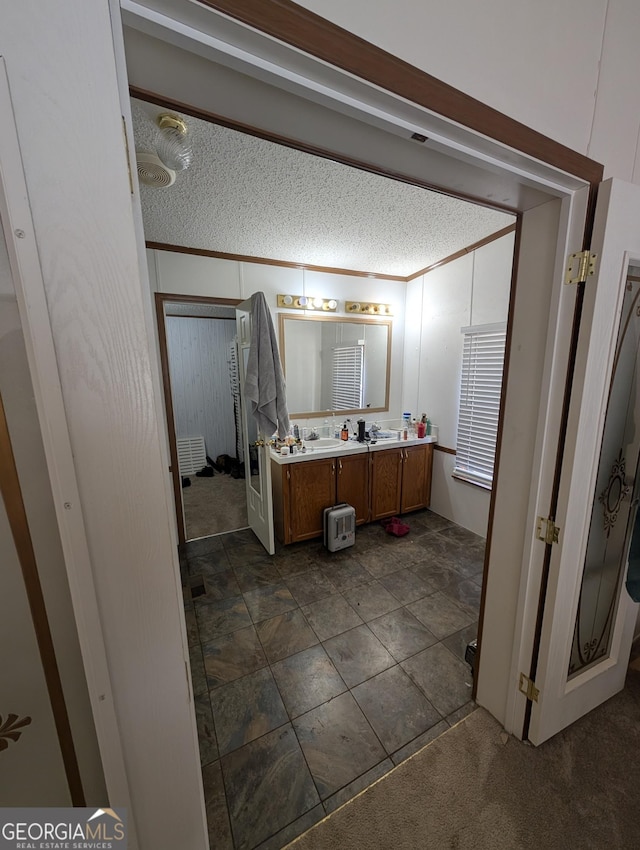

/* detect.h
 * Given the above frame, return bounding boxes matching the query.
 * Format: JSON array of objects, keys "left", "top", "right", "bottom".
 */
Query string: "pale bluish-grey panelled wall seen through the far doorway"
[{"left": 166, "top": 316, "right": 237, "bottom": 460}]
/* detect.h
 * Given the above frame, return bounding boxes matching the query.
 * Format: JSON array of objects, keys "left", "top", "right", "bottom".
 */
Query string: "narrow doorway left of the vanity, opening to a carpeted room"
[{"left": 156, "top": 293, "right": 250, "bottom": 543}]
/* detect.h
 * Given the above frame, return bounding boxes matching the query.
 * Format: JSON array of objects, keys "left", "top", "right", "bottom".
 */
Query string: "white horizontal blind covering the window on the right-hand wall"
[{"left": 453, "top": 324, "right": 507, "bottom": 488}]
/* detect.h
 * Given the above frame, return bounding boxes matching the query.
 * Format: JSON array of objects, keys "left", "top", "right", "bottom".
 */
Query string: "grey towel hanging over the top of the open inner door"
[{"left": 244, "top": 292, "right": 289, "bottom": 438}]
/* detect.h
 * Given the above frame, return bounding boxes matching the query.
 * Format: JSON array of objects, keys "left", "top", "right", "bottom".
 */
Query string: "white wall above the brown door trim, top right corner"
[{"left": 298, "top": 0, "right": 640, "bottom": 182}]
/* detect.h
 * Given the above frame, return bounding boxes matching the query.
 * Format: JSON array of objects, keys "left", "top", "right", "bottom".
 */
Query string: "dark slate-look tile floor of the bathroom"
[{"left": 181, "top": 511, "right": 484, "bottom": 850}]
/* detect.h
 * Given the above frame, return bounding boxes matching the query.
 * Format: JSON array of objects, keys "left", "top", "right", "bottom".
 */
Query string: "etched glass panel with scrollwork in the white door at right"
[{"left": 569, "top": 266, "right": 640, "bottom": 676}]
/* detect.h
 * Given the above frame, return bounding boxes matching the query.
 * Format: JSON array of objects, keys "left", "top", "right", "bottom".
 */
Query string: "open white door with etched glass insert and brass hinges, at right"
[{"left": 528, "top": 180, "right": 640, "bottom": 744}]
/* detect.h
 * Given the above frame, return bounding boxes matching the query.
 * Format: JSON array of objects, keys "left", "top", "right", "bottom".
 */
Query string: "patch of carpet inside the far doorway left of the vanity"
[{"left": 182, "top": 473, "right": 247, "bottom": 540}]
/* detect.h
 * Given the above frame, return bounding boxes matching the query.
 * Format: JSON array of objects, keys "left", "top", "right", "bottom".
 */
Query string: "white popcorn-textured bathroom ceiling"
[{"left": 132, "top": 99, "right": 514, "bottom": 276}]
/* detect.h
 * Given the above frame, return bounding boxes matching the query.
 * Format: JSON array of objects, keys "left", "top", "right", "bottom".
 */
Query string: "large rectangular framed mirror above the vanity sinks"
[{"left": 279, "top": 313, "right": 391, "bottom": 417}]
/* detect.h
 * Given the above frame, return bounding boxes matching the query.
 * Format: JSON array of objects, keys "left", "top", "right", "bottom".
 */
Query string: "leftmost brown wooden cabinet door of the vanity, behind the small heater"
[{"left": 287, "top": 457, "right": 336, "bottom": 543}]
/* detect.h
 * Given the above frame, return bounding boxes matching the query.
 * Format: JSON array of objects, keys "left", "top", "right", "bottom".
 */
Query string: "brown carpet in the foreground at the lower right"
[{"left": 289, "top": 669, "right": 640, "bottom": 850}]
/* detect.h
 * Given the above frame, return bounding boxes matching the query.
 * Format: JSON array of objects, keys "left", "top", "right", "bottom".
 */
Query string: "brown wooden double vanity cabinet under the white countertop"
[{"left": 271, "top": 437, "right": 435, "bottom": 544}]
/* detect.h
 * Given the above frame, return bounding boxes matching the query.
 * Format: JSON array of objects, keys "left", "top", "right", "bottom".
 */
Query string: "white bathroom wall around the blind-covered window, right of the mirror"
[{"left": 404, "top": 233, "right": 514, "bottom": 536}]
